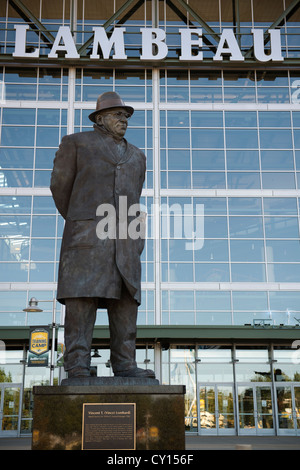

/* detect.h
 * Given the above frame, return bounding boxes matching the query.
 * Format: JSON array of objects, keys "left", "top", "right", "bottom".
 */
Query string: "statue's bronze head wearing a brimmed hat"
[{"left": 89, "top": 91, "right": 134, "bottom": 138}]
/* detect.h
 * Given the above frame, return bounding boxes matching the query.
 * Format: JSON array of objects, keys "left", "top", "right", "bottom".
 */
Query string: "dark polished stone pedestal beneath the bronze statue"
[{"left": 32, "top": 377, "right": 185, "bottom": 450}]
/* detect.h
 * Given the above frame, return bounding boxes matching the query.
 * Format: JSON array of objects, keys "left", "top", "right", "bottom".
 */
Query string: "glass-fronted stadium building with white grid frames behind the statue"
[{"left": 0, "top": 0, "right": 300, "bottom": 437}]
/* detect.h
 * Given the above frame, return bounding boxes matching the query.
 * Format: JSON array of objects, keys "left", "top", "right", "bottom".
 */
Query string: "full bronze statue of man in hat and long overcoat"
[{"left": 50, "top": 92, "right": 155, "bottom": 378}]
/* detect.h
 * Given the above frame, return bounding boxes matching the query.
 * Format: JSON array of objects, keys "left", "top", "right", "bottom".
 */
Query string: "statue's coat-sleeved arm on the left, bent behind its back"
[{"left": 50, "top": 136, "right": 77, "bottom": 219}]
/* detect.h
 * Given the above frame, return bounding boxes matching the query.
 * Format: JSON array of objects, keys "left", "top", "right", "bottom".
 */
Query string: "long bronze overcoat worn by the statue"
[{"left": 50, "top": 126, "right": 146, "bottom": 307}]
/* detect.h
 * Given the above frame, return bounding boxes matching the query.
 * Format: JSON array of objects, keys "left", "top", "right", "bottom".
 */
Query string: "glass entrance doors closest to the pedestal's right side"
[{"left": 198, "top": 384, "right": 235, "bottom": 435}]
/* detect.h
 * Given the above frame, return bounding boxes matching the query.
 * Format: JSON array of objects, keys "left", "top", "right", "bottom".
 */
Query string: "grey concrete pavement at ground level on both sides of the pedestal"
[{"left": 0, "top": 435, "right": 300, "bottom": 451}]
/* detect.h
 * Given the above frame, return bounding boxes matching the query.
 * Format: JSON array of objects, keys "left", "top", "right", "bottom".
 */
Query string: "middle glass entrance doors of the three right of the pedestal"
[{"left": 237, "top": 383, "right": 275, "bottom": 435}]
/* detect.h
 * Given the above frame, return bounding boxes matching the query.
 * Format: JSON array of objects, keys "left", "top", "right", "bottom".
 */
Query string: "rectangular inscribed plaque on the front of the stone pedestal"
[{"left": 82, "top": 403, "right": 136, "bottom": 450}]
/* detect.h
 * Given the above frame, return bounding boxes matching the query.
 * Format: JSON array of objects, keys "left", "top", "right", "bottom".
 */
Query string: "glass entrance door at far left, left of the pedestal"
[{"left": 0, "top": 383, "right": 21, "bottom": 437}]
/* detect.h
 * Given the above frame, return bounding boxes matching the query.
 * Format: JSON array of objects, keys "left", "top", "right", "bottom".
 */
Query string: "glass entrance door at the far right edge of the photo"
[{"left": 276, "top": 383, "right": 300, "bottom": 436}]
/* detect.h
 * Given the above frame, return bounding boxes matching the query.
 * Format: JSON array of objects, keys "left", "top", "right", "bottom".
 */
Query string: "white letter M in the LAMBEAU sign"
[{"left": 91, "top": 27, "right": 127, "bottom": 59}]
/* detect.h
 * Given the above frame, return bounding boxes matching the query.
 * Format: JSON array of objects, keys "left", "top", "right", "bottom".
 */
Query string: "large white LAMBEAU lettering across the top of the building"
[{"left": 12, "top": 24, "right": 284, "bottom": 62}]
